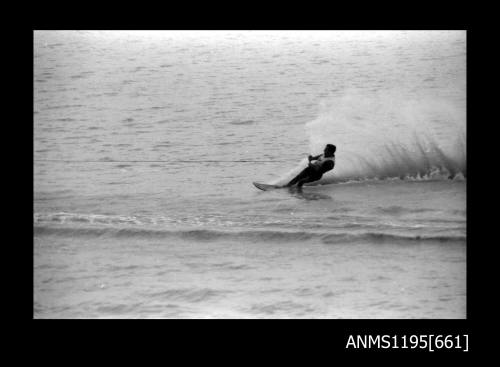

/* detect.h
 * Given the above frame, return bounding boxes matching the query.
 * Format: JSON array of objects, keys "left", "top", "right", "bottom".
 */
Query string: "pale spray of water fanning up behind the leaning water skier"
[{"left": 275, "top": 92, "right": 467, "bottom": 184}]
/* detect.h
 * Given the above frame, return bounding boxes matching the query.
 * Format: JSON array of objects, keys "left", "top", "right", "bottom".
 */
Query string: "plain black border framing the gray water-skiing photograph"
[{"left": 16, "top": 2, "right": 488, "bottom": 360}]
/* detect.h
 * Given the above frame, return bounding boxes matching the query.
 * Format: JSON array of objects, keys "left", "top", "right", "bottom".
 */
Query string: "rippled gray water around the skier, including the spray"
[{"left": 34, "top": 31, "right": 466, "bottom": 318}]
